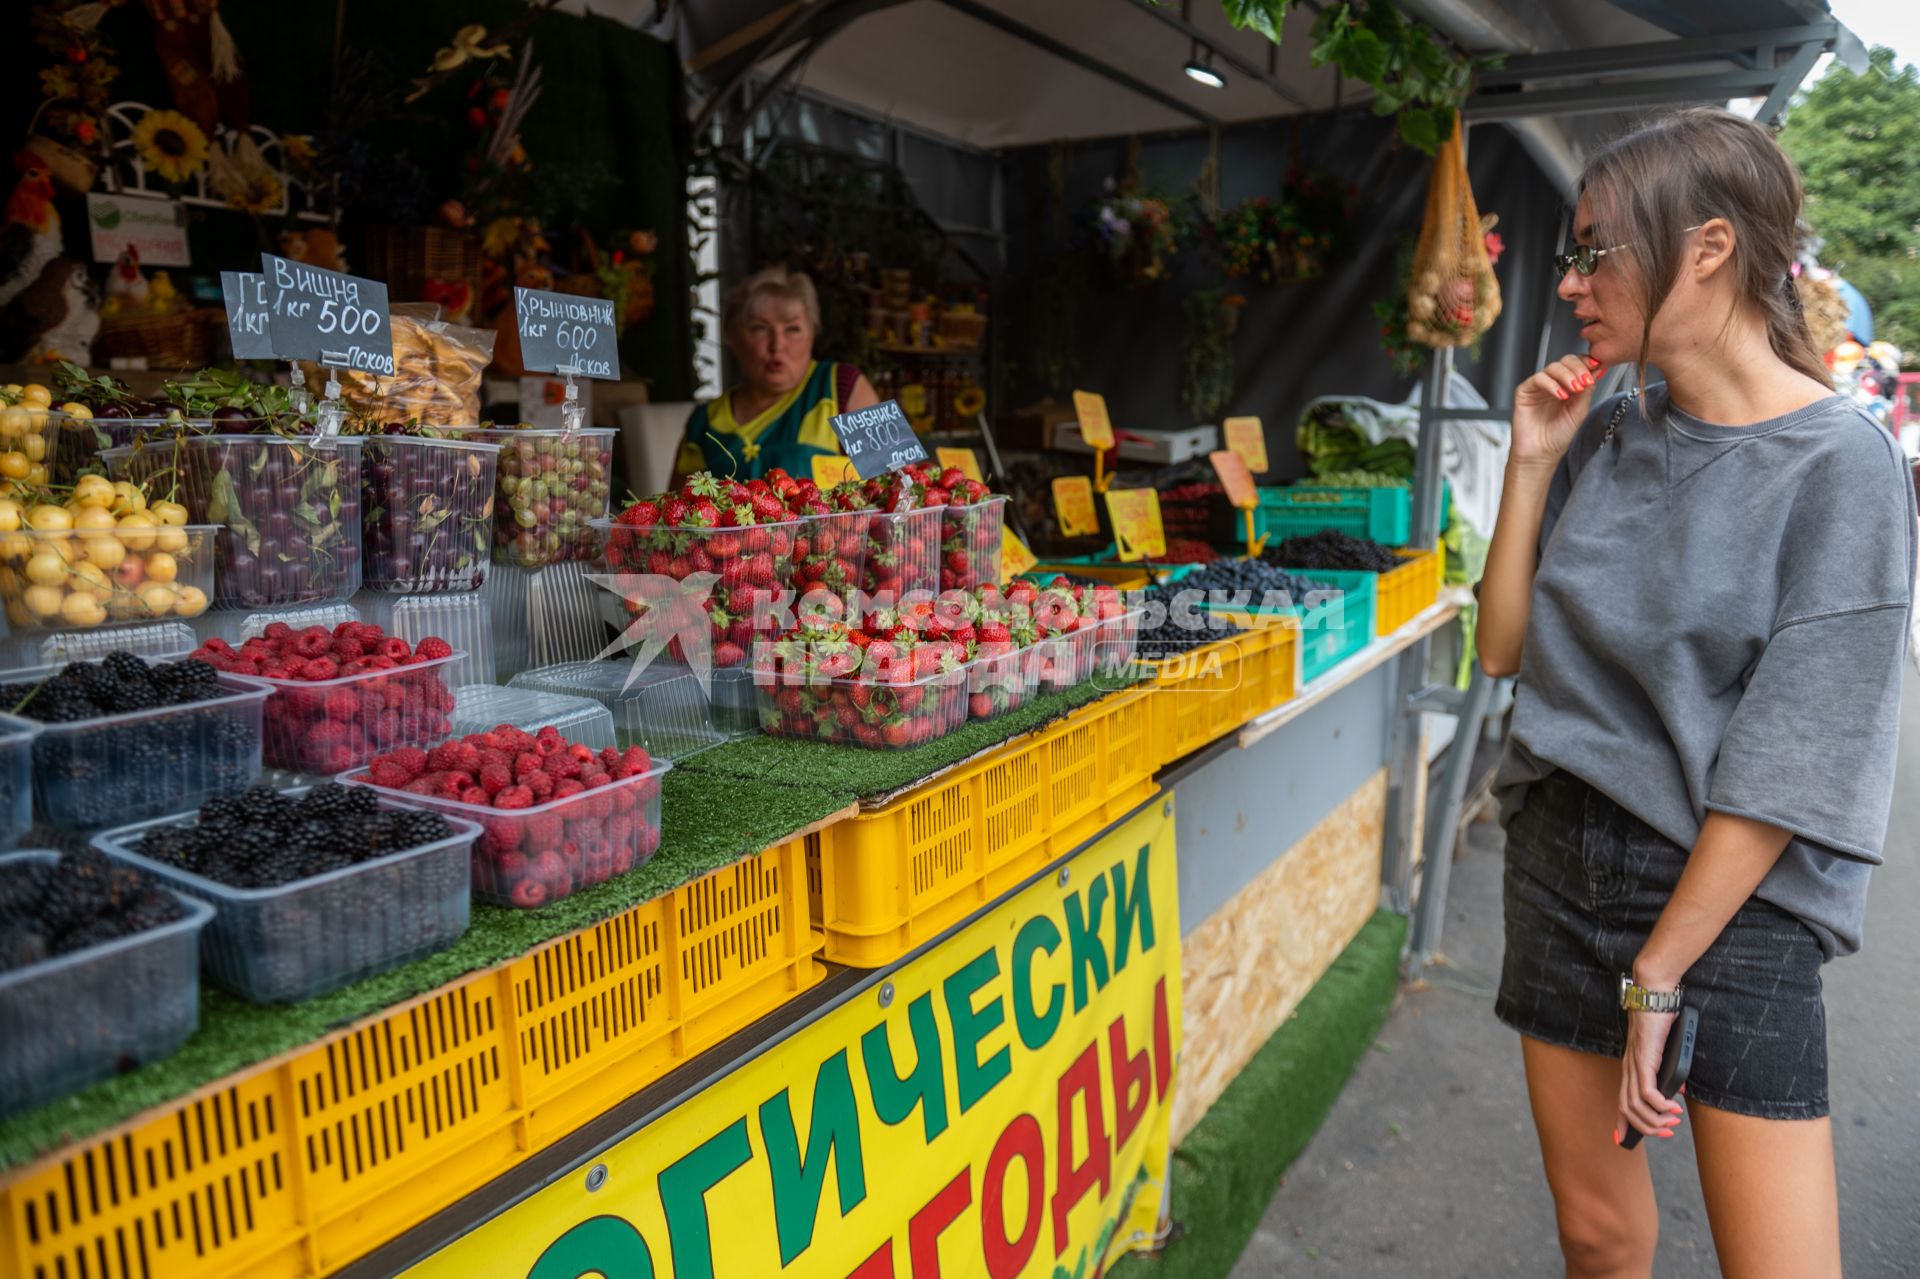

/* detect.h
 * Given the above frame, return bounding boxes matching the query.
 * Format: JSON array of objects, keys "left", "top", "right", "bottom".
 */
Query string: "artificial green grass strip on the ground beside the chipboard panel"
[{"left": 1110, "top": 910, "right": 1407, "bottom": 1279}]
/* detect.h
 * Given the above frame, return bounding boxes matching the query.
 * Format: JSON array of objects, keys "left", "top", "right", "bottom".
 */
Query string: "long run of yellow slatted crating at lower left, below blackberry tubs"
[{"left": 0, "top": 839, "right": 826, "bottom": 1279}]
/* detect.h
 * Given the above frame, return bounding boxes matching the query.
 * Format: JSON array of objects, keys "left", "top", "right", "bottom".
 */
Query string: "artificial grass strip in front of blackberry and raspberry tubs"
[{"left": 0, "top": 768, "right": 854, "bottom": 1170}]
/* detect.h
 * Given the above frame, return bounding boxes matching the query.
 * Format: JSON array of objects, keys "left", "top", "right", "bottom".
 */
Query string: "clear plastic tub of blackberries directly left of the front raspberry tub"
[{"left": 94, "top": 787, "right": 480, "bottom": 1004}]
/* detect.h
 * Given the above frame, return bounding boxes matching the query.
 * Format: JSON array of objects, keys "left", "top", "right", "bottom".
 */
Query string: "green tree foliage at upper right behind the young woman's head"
[{"left": 1780, "top": 46, "right": 1920, "bottom": 363}]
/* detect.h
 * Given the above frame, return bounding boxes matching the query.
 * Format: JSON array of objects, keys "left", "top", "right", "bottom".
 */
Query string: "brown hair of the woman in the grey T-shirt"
[{"left": 1580, "top": 108, "right": 1834, "bottom": 386}]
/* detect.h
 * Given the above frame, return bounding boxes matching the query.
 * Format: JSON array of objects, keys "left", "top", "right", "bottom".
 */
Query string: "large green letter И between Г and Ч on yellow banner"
[{"left": 760, "top": 1049, "right": 866, "bottom": 1266}]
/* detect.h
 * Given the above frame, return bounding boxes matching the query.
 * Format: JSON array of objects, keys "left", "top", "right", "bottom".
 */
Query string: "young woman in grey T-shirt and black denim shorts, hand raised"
[{"left": 1476, "top": 109, "right": 1916, "bottom": 1279}]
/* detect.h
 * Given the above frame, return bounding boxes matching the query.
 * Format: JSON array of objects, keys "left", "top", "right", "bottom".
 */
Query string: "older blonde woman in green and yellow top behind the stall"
[{"left": 678, "top": 267, "right": 879, "bottom": 480}]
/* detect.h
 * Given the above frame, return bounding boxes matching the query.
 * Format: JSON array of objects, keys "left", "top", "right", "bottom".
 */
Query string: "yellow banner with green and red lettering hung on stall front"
[{"left": 405, "top": 799, "right": 1181, "bottom": 1279}]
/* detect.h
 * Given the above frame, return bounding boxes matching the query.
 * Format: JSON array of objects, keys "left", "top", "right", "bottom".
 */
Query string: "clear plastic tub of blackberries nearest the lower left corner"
[{"left": 0, "top": 851, "right": 213, "bottom": 1116}]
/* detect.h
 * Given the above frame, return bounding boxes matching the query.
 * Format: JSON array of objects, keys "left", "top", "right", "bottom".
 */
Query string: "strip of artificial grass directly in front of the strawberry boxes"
[{"left": 685, "top": 684, "right": 1116, "bottom": 799}]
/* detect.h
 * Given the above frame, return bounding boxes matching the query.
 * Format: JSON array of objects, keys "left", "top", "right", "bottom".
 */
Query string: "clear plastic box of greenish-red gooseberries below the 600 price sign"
[{"left": 455, "top": 426, "right": 616, "bottom": 568}]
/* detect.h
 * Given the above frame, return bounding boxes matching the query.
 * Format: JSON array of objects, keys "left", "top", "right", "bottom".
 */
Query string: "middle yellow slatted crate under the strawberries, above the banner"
[{"left": 808, "top": 689, "right": 1154, "bottom": 968}]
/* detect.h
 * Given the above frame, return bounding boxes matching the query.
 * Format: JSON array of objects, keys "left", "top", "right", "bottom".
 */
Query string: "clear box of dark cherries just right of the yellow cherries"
[{"left": 102, "top": 434, "right": 363, "bottom": 609}]
